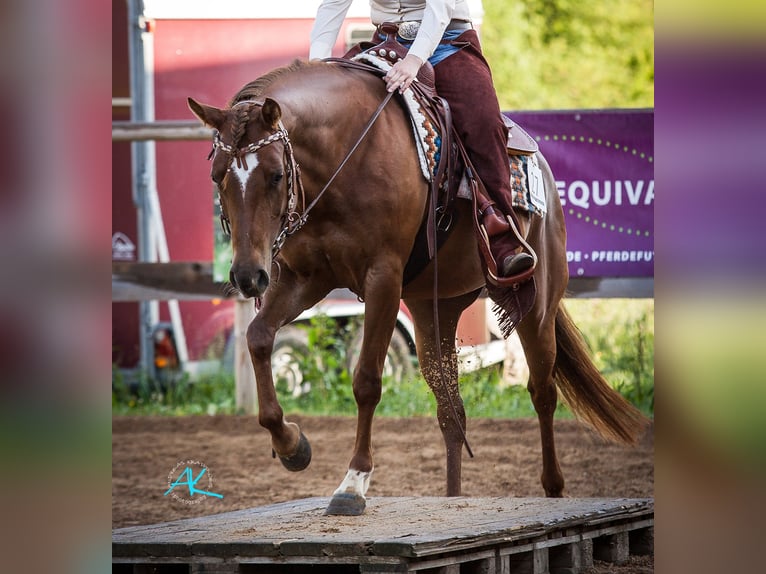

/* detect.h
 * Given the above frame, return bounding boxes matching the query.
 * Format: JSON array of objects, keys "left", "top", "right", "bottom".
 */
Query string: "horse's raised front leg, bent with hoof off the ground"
[{"left": 247, "top": 267, "right": 327, "bottom": 471}]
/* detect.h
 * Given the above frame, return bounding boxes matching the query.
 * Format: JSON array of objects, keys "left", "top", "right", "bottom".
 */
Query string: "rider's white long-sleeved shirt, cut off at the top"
[{"left": 309, "top": 0, "right": 471, "bottom": 62}]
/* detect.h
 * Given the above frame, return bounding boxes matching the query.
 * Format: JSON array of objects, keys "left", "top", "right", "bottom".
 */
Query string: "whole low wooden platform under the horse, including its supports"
[{"left": 112, "top": 497, "right": 654, "bottom": 574}]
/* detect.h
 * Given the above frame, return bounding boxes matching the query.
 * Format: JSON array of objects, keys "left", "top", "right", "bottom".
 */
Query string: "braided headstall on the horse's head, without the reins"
[{"left": 208, "top": 101, "right": 306, "bottom": 258}]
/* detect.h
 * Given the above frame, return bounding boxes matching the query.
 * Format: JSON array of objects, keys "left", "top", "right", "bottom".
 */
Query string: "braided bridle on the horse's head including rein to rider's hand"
[{"left": 208, "top": 92, "right": 394, "bottom": 259}]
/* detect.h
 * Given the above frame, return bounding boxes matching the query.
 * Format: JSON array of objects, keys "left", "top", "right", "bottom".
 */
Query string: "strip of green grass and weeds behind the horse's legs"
[{"left": 112, "top": 299, "right": 654, "bottom": 418}]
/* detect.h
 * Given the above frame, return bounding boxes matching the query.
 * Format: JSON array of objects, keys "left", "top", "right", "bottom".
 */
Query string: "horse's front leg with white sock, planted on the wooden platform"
[{"left": 325, "top": 275, "right": 401, "bottom": 516}]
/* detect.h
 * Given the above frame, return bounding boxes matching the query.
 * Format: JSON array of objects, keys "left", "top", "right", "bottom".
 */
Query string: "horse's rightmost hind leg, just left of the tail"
[{"left": 518, "top": 294, "right": 564, "bottom": 497}]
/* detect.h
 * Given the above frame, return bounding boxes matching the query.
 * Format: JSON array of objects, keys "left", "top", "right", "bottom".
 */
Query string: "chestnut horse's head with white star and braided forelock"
[{"left": 188, "top": 98, "right": 296, "bottom": 297}]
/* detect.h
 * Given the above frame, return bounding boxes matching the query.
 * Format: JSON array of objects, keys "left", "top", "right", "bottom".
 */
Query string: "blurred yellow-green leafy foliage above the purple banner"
[{"left": 481, "top": 0, "right": 654, "bottom": 110}]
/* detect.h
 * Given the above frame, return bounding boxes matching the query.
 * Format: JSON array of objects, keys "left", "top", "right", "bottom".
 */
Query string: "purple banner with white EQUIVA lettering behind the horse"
[{"left": 507, "top": 110, "right": 654, "bottom": 277}]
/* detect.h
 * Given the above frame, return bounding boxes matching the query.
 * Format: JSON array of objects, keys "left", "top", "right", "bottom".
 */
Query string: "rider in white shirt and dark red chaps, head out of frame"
[{"left": 309, "top": 0, "right": 534, "bottom": 277}]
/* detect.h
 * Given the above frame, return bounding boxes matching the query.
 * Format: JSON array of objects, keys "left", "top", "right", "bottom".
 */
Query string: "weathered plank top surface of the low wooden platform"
[{"left": 112, "top": 497, "right": 654, "bottom": 571}]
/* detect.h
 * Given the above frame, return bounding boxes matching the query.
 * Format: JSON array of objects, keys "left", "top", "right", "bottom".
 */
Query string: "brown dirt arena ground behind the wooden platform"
[{"left": 112, "top": 416, "right": 654, "bottom": 574}]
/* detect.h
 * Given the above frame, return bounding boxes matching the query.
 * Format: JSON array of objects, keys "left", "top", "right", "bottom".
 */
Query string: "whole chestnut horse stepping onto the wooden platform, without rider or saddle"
[{"left": 188, "top": 61, "right": 645, "bottom": 514}]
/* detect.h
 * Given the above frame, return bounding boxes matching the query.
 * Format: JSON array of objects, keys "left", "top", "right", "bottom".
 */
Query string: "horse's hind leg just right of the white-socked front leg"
[{"left": 405, "top": 291, "right": 479, "bottom": 496}]
